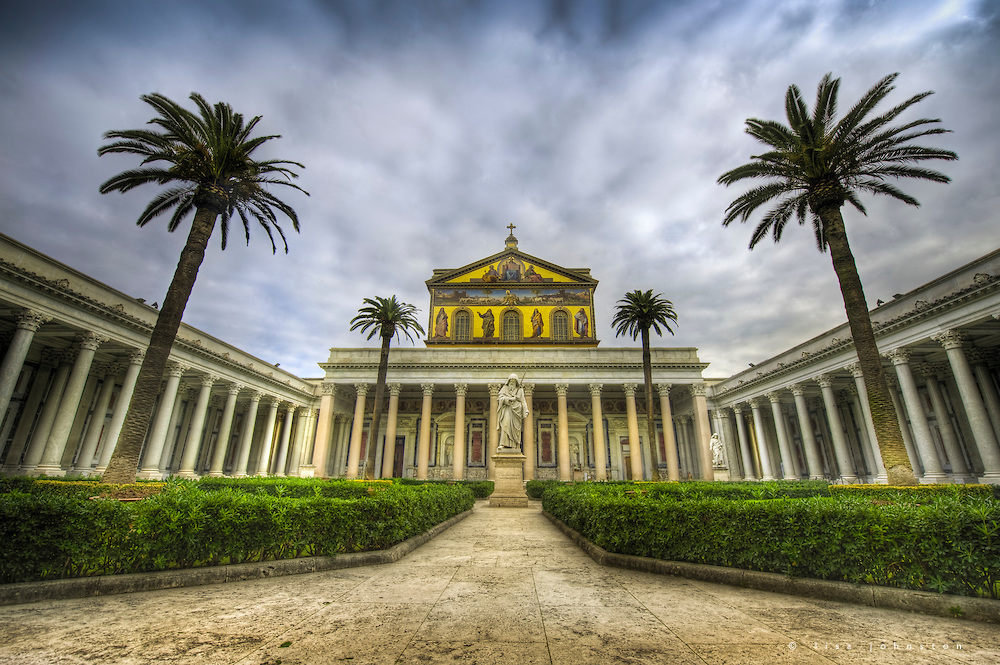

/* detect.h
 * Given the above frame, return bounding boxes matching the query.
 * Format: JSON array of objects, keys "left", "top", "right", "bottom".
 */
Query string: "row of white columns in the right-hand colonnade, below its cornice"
[{"left": 715, "top": 329, "right": 1000, "bottom": 483}]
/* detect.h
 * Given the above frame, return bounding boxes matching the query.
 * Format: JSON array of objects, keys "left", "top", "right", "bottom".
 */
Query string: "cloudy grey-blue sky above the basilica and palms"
[{"left": 0, "top": 0, "right": 1000, "bottom": 377}]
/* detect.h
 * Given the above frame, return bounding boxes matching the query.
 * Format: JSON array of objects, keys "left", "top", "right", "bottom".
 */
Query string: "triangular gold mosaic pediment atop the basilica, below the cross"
[{"left": 427, "top": 249, "right": 597, "bottom": 287}]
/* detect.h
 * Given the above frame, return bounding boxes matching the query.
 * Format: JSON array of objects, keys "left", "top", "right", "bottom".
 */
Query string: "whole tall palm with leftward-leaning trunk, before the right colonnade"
[{"left": 719, "top": 74, "right": 958, "bottom": 485}]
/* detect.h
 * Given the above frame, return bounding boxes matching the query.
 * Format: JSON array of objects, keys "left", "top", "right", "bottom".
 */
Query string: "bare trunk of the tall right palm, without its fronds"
[{"left": 818, "top": 206, "right": 917, "bottom": 485}]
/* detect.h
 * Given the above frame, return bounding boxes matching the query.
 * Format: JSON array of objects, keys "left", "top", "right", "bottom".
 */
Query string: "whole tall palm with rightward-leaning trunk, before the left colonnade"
[{"left": 97, "top": 93, "right": 308, "bottom": 483}]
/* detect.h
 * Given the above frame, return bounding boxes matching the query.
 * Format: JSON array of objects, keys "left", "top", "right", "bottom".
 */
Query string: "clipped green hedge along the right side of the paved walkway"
[{"left": 542, "top": 484, "right": 1000, "bottom": 598}]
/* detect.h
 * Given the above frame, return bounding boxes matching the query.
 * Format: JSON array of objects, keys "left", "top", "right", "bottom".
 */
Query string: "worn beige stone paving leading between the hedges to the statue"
[{"left": 0, "top": 502, "right": 1000, "bottom": 665}]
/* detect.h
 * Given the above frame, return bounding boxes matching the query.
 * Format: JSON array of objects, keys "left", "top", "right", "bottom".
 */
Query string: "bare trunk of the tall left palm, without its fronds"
[{"left": 103, "top": 207, "right": 223, "bottom": 484}]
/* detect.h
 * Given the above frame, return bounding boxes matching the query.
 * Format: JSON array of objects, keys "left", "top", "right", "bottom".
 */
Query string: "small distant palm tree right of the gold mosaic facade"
[{"left": 611, "top": 289, "right": 677, "bottom": 480}]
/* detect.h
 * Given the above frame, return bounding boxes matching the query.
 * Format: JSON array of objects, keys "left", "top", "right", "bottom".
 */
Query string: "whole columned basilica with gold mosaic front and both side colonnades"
[{"left": 0, "top": 227, "right": 1000, "bottom": 483}]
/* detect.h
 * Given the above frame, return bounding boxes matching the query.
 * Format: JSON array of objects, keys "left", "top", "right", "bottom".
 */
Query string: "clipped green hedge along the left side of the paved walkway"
[{"left": 0, "top": 483, "right": 475, "bottom": 582}]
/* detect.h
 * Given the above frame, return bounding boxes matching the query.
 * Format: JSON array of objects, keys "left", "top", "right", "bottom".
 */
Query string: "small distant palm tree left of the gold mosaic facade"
[{"left": 351, "top": 296, "right": 424, "bottom": 480}]
